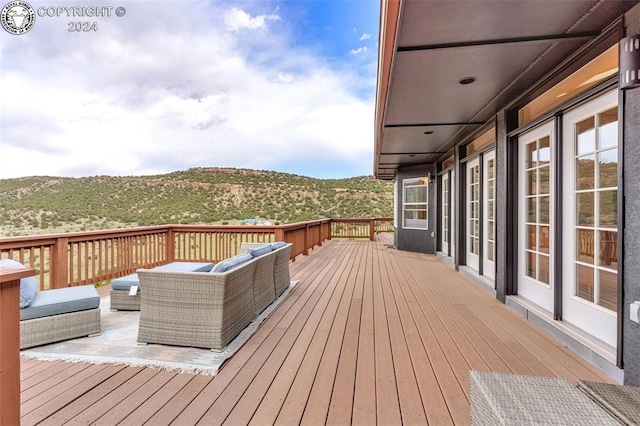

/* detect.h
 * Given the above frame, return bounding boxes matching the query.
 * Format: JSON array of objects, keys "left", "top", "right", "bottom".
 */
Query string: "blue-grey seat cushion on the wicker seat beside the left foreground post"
[{"left": 20, "top": 284, "right": 100, "bottom": 321}]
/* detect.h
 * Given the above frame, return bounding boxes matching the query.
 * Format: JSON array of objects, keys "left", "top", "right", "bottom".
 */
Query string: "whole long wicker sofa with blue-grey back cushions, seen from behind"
[{"left": 138, "top": 244, "right": 291, "bottom": 350}]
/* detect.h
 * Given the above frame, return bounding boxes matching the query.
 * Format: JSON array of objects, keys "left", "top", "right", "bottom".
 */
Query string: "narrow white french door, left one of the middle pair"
[{"left": 466, "top": 158, "right": 480, "bottom": 270}]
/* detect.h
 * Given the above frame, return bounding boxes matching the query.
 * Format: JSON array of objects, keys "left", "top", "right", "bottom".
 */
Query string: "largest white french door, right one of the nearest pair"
[{"left": 562, "top": 90, "right": 618, "bottom": 347}]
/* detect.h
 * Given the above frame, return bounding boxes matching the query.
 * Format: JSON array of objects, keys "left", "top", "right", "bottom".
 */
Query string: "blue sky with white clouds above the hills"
[{"left": 0, "top": 0, "right": 380, "bottom": 178}]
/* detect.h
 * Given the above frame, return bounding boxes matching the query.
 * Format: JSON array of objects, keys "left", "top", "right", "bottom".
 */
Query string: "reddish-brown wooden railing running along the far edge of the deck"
[{"left": 0, "top": 218, "right": 393, "bottom": 290}]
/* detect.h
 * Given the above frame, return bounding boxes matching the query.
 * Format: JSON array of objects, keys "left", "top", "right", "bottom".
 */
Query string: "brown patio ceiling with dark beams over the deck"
[{"left": 374, "top": 0, "right": 638, "bottom": 179}]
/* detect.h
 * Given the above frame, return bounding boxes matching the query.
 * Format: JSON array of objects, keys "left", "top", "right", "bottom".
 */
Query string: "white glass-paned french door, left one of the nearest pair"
[{"left": 518, "top": 121, "right": 556, "bottom": 312}]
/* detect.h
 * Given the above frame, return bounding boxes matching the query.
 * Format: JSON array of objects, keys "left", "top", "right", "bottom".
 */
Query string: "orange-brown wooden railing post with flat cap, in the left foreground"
[{"left": 0, "top": 268, "right": 35, "bottom": 426}]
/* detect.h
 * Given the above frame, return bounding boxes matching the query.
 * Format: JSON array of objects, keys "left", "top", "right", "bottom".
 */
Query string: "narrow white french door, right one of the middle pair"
[{"left": 482, "top": 150, "right": 496, "bottom": 279}]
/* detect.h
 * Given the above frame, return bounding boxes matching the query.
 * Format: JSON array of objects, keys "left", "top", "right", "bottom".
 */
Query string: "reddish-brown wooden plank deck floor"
[{"left": 21, "top": 235, "right": 613, "bottom": 425}]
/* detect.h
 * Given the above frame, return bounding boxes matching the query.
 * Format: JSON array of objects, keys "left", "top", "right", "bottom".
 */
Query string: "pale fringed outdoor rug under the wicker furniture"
[{"left": 20, "top": 281, "right": 297, "bottom": 376}]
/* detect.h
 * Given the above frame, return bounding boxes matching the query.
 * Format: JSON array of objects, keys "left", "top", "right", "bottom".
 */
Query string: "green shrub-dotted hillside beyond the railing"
[{"left": 0, "top": 168, "right": 393, "bottom": 237}]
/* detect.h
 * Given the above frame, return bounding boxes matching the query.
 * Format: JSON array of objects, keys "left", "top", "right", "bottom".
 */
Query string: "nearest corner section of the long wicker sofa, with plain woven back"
[{"left": 138, "top": 259, "right": 256, "bottom": 350}]
